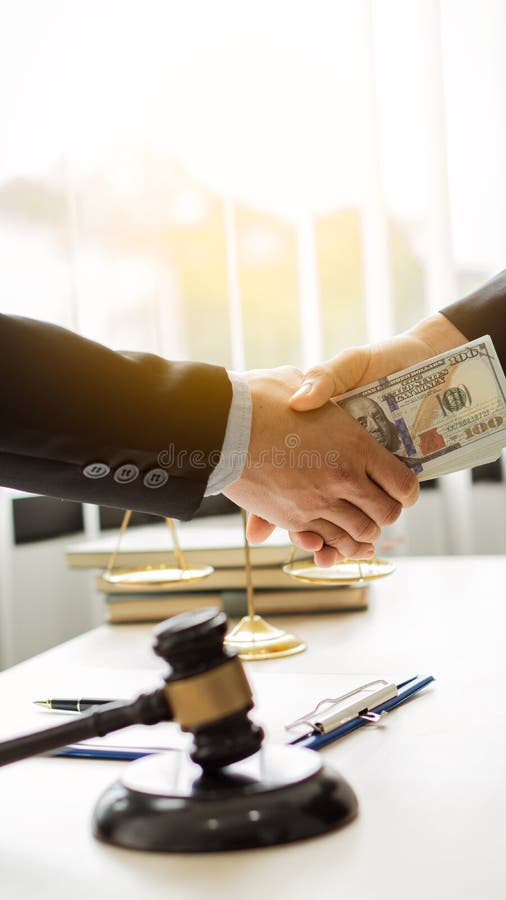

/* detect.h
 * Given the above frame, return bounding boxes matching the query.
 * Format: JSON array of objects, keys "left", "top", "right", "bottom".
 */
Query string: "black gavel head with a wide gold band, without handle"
[{"left": 153, "top": 609, "right": 264, "bottom": 772}]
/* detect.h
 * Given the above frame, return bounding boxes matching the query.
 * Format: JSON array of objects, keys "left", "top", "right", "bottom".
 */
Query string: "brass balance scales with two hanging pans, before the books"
[{"left": 102, "top": 509, "right": 395, "bottom": 661}]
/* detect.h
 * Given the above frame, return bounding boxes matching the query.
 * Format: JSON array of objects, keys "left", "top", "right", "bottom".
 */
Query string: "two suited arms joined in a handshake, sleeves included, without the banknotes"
[{"left": 0, "top": 270, "right": 500, "bottom": 552}]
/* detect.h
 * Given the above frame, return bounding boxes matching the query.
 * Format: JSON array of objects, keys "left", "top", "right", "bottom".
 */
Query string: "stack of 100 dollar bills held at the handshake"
[{"left": 334, "top": 335, "right": 506, "bottom": 481}]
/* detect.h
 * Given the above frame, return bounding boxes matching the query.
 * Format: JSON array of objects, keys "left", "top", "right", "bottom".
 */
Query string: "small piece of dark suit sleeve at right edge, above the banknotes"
[{"left": 441, "top": 269, "right": 506, "bottom": 371}]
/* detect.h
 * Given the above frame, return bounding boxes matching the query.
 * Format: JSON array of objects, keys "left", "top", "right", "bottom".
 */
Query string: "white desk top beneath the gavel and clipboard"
[{"left": 0, "top": 557, "right": 506, "bottom": 900}]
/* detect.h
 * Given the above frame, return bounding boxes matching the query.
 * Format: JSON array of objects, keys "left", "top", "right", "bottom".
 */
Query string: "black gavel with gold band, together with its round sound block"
[{"left": 0, "top": 609, "right": 358, "bottom": 852}]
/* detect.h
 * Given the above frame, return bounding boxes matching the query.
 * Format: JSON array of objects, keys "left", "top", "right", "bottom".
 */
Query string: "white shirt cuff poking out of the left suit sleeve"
[{"left": 204, "top": 372, "right": 252, "bottom": 497}]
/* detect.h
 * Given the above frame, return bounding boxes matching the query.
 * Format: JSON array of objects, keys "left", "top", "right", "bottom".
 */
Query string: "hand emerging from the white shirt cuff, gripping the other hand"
[{"left": 224, "top": 367, "right": 418, "bottom": 565}]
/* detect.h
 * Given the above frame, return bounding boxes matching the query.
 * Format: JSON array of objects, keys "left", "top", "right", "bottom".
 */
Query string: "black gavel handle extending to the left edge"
[{"left": 0, "top": 688, "right": 173, "bottom": 766}]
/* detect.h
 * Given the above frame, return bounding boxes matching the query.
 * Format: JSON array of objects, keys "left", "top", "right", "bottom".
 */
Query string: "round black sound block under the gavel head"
[{"left": 93, "top": 745, "right": 358, "bottom": 853}]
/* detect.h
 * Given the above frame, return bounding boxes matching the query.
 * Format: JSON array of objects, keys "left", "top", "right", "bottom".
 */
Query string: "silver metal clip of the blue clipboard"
[{"left": 285, "top": 678, "right": 398, "bottom": 734}]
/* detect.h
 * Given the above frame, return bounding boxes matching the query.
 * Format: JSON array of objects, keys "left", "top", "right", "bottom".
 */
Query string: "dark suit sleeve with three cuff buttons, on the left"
[{"left": 0, "top": 315, "right": 232, "bottom": 519}]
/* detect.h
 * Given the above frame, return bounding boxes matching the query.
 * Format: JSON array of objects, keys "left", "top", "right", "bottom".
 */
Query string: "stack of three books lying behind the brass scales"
[{"left": 67, "top": 514, "right": 367, "bottom": 623}]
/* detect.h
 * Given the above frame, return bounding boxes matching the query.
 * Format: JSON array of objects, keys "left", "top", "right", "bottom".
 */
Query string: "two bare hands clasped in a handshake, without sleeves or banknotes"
[{"left": 224, "top": 313, "right": 476, "bottom": 566}]
